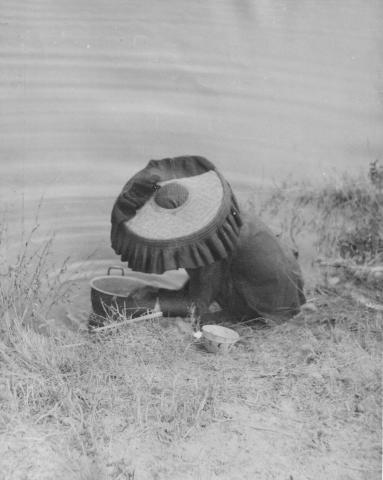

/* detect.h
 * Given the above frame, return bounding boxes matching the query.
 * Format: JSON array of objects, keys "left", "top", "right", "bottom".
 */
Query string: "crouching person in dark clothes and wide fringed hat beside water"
[{"left": 111, "top": 156, "right": 305, "bottom": 321}]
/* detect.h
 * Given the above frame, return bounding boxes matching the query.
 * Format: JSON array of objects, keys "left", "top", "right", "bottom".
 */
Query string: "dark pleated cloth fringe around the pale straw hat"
[{"left": 111, "top": 156, "right": 242, "bottom": 274}]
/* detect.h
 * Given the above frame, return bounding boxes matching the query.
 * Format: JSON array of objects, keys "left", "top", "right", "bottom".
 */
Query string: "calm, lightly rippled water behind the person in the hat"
[{"left": 0, "top": 0, "right": 383, "bottom": 316}]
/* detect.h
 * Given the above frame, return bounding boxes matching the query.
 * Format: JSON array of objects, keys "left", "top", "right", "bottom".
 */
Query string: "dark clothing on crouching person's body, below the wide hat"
[{"left": 187, "top": 218, "right": 306, "bottom": 321}]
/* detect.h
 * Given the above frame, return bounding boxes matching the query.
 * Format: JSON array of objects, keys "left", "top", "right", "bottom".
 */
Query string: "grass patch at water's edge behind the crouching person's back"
[{"left": 245, "top": 164, "right": 383, "bottom": 263}]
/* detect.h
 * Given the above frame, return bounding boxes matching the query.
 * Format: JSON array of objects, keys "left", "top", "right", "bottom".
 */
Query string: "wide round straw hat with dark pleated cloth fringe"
[{"left": 111, "top": 156, "right": 242, "bottom": 273}]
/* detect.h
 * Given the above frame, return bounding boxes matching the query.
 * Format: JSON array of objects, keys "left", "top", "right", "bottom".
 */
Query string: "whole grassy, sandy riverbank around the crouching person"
[{"left": 0, "top": 167, "right": 383, "bottom": 480}]
